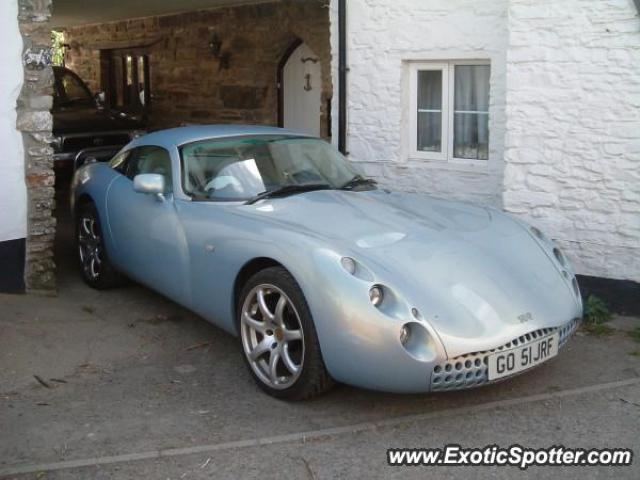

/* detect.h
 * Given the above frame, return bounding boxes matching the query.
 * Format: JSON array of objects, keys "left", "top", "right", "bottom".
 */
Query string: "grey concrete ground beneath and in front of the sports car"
[{"left": 0, "top": 208, "right": 640, "bottom": 480}]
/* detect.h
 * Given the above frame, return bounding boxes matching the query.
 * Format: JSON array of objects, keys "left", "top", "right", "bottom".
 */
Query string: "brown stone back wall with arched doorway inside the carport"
[{"left": 65, "top": 0, "right": 332, "bottom": 136}]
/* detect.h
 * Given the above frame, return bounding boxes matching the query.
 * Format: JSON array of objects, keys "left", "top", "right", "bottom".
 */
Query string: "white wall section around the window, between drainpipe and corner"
[{"left": 331, "top": 0, "right": 507, "bottom": 206}]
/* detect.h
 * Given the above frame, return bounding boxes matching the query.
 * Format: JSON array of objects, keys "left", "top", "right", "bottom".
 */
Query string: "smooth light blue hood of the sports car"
[{"left": 241, "top": 190, "right": 580, "bottom": 356}]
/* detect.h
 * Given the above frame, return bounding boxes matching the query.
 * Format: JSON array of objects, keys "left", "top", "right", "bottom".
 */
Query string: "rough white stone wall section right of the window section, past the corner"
[{"left": 504, "top": 0, "right": 640, "bottom": 281}]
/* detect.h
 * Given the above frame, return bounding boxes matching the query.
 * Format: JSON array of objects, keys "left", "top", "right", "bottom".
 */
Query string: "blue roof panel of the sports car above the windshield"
[{"left": 129, "top": 125, "right": 308, "bottom": 148}]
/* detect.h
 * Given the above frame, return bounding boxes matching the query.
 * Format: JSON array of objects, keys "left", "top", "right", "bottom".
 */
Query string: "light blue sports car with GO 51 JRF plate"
[{"left": 72, "top": 126, "right": 582, "bottom": 399}]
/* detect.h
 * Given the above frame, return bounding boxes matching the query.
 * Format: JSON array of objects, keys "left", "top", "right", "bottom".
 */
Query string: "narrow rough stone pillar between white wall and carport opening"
[{"left": 17, "top": 0, "right": 56, "bottom": 292}]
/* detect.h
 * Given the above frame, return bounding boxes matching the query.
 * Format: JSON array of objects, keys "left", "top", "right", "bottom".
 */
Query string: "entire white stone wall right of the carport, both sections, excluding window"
[{"left": 331, "top": 0, "right": 640, "bottom": 281}]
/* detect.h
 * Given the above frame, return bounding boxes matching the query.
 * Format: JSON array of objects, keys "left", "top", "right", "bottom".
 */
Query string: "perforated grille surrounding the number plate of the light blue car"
[{"left": 431, "top": 318, "right": 580, "bottom": 391}]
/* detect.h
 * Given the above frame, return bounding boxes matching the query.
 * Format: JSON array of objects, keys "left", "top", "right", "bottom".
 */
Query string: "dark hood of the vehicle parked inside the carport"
[{"left": 53, "top": 107, "right": 142, "bottom": 135}]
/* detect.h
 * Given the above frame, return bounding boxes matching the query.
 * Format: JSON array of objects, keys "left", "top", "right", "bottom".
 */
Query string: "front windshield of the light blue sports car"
[{"left": 180, "top": 135, "right": 358, "bottom": 201}]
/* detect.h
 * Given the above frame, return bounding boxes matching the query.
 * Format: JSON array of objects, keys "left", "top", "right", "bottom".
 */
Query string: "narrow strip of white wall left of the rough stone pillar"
[{"left": 0, "top": 0, "right": 27, "bottom": 242}]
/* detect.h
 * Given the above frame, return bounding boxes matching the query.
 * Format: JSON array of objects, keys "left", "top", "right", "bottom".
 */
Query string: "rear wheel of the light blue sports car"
[{"left": 75, "top": 202, "right": 124, "bottom": 290}]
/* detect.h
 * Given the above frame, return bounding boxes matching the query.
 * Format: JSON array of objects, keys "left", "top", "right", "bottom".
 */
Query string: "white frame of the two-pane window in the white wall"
[{"left": 409, "top": 59, "right": 491, "bottom": 164}]
